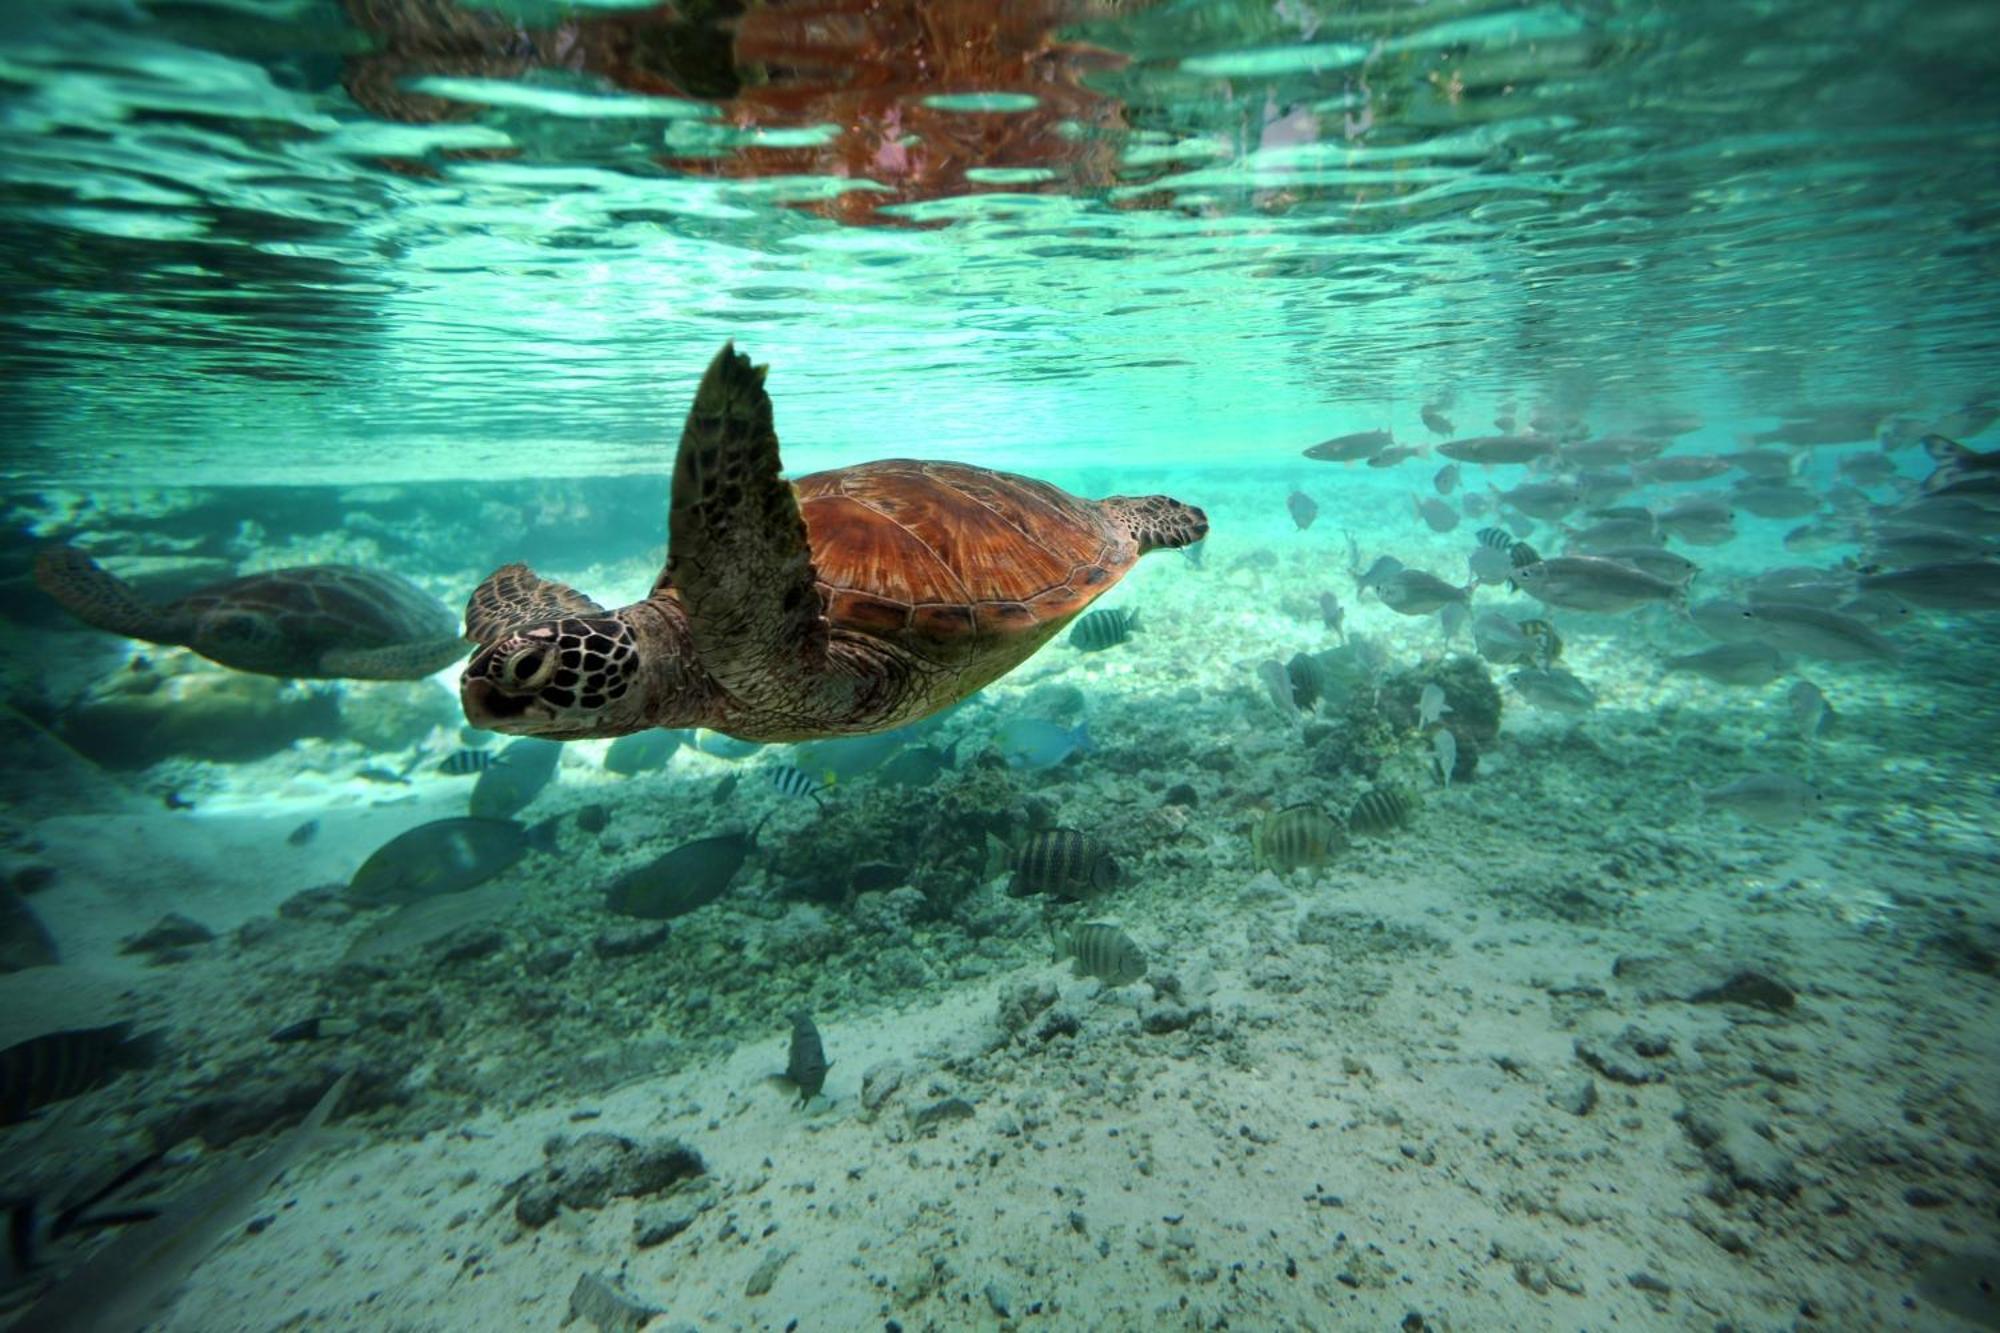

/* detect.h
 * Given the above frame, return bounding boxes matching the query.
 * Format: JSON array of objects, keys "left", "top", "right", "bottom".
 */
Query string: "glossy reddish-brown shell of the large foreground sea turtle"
[{"left": 794, "top": 458, "right": 1138, "bottom": 671}]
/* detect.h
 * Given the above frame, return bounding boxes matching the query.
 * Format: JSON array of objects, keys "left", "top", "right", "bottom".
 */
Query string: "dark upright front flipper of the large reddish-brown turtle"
[{"left": 662, "top": 346, "right": 828, "bottom": 713}]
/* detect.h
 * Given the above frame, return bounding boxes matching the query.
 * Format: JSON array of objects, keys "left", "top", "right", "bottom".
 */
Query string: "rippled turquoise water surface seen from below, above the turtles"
[{"left": 0, "top": 0, "right": 2000, "bottom": 482}]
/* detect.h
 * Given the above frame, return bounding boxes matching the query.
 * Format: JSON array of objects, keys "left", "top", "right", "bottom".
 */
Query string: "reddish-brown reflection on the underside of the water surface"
[{"left": 344, "top": 0, "right": 1136, "bottom": 224}]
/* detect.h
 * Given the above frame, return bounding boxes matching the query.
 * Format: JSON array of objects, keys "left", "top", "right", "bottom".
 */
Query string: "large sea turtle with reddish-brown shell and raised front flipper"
[{"left": 460, "top": 346, "right": 1208, "bottom": 741}]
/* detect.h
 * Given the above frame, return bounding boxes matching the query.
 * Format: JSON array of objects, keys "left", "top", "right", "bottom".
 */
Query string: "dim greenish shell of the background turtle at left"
[{"left": 166, "top": 564, "right": 458, "bottom": 677}]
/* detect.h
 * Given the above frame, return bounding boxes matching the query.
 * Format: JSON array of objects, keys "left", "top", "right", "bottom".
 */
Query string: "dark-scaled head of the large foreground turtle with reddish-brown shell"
[{"left": 458, "top": 616, "right": 658, "bottom": 741}]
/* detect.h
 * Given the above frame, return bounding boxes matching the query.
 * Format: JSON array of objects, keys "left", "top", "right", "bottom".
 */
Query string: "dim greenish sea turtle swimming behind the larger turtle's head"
[{"left": 34, "top": 546, "right": 468, "bottom": 681}]
